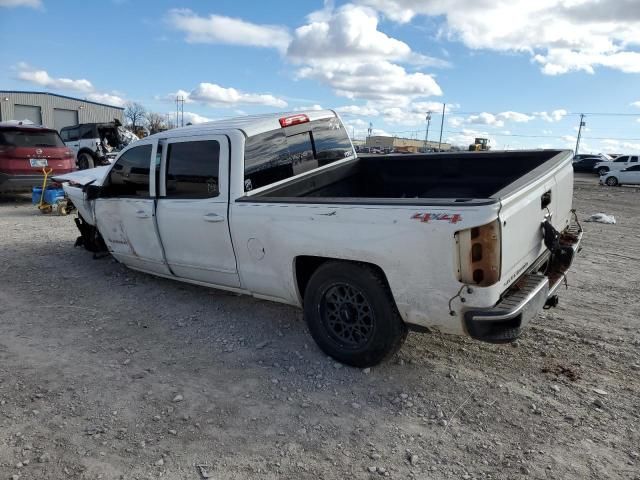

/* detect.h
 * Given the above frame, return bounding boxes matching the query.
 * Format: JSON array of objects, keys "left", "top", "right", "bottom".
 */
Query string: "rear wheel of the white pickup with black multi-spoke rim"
[{"left": 304, "top": 262, "right": 408, "bottom": 368}]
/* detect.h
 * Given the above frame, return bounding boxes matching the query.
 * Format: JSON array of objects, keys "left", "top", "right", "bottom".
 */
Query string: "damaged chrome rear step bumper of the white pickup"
[{"left": 464, "top": 222, "right": 582, "bottom": 343}]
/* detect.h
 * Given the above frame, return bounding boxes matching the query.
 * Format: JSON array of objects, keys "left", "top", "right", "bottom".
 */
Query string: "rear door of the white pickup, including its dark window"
[{"left": 157, "top": 135, "right": 240, "bottom": 287}]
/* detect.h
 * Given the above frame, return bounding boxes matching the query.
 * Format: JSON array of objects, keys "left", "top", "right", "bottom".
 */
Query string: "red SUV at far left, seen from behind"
[{"left": 0, "top": 123, "right": 75, "bottom": 192}]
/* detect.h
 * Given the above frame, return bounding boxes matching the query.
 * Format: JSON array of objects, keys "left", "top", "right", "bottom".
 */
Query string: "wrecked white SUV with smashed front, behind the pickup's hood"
[{"left": 60, "top": 121, "right": 138, "bottom": 170}]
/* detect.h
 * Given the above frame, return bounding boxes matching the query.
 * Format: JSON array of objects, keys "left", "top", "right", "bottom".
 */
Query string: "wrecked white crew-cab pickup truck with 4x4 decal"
[{"left": 56, "top": 110, "right": 582, "bottom": 367}]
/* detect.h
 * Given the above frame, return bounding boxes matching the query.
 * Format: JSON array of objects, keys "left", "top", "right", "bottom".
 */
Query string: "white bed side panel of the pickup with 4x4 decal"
[{"left": 230, "top": 202, "right": 498, "bottom": 333}]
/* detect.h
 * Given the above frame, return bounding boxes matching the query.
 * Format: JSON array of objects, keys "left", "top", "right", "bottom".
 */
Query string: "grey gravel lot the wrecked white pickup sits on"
[{"left": 0, "top": 177, "right": 640, "bottom": 480}]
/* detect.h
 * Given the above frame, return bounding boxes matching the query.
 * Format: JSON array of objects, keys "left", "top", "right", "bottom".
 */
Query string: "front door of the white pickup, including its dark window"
[{"left": 95, "top": 141, "right": 171, "bottom": 275}]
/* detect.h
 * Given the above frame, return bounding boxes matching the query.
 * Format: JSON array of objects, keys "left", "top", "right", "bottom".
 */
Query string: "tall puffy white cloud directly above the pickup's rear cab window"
[{"left": 287, "top": 2, "right": 442, "bottom": 106}]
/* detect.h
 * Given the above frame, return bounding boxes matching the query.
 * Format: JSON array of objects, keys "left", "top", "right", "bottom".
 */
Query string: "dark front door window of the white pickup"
[{"left": 100, "top": 145, "right": 151, "bottom": 197}]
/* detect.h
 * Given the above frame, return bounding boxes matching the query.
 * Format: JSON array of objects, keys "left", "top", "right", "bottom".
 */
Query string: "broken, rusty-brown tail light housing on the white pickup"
[{"left": 455, "top": 219, "right": 501, "bottom": 287}]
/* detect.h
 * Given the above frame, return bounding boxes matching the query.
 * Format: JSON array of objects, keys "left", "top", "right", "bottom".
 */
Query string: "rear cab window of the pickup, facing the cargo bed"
[{"left": 244, "top": 117, "right": 353, "bottom": 191}]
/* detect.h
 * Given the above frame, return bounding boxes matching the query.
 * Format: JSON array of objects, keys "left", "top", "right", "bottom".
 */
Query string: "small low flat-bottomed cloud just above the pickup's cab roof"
[{"left": 164, "top": 82, "right": 287, "bottom": 108}]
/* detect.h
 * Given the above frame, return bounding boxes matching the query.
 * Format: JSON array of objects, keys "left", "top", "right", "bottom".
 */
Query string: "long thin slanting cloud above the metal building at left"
[{"left": 15, "top": 62, "right": 126, "bottom": 107}]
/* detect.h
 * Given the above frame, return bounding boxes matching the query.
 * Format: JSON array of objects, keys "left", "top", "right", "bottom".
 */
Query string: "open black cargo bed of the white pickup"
[{"left": 240, "top": 150, "right": 566, "bottom": 204}]
